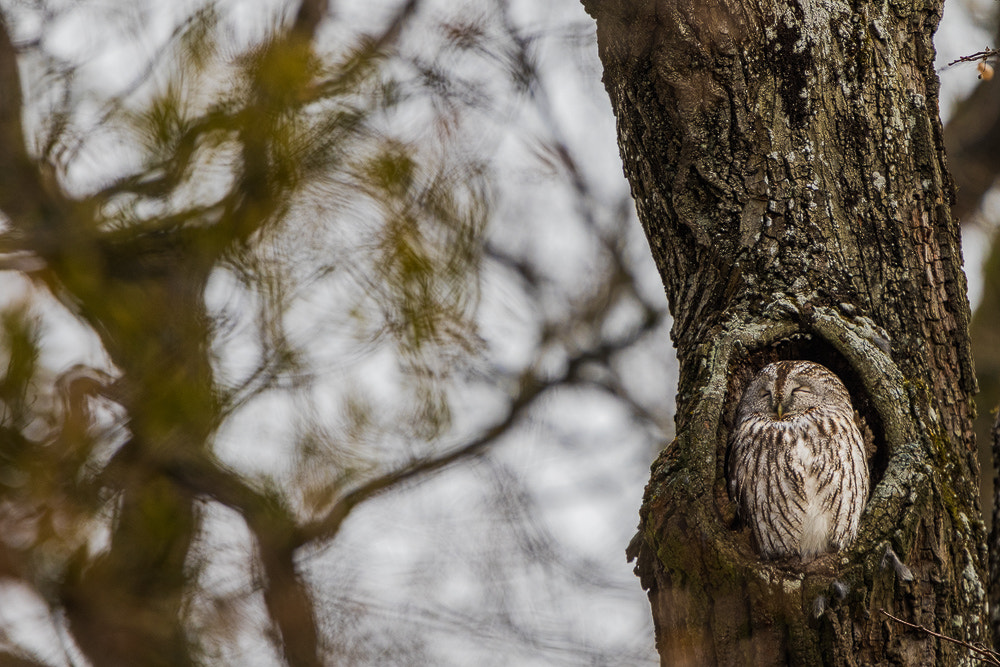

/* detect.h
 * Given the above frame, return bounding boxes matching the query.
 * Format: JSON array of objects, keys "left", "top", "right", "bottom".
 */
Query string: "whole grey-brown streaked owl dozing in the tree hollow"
[{"left": 728, "top": 361, "right": 869, "bottom": 562}]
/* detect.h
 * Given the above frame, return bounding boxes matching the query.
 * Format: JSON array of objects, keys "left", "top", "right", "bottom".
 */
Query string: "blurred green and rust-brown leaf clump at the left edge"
[{"left": 0, "top": 305, "right": 102, "bottom": 591}]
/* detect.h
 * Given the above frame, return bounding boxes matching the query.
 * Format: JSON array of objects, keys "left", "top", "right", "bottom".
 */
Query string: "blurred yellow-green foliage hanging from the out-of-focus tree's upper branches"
[{"left": 93, "top": 1, "right": 490, "bottom": 434}]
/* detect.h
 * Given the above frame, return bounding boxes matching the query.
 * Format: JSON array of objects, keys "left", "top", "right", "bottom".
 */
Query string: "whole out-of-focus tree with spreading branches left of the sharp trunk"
[{"left": 0, "top": 1, "right": 666, "bottom": 665}]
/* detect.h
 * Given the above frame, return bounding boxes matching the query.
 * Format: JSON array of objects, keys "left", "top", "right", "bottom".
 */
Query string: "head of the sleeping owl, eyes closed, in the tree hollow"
[{"left": 736, "top": 361, "right": 850, "bottom": 422}]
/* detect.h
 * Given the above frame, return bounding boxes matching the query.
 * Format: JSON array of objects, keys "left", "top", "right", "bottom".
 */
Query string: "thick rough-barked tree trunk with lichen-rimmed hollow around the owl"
[{"left": 584, "top": 0, "right": 989, "bottom": 665}]
